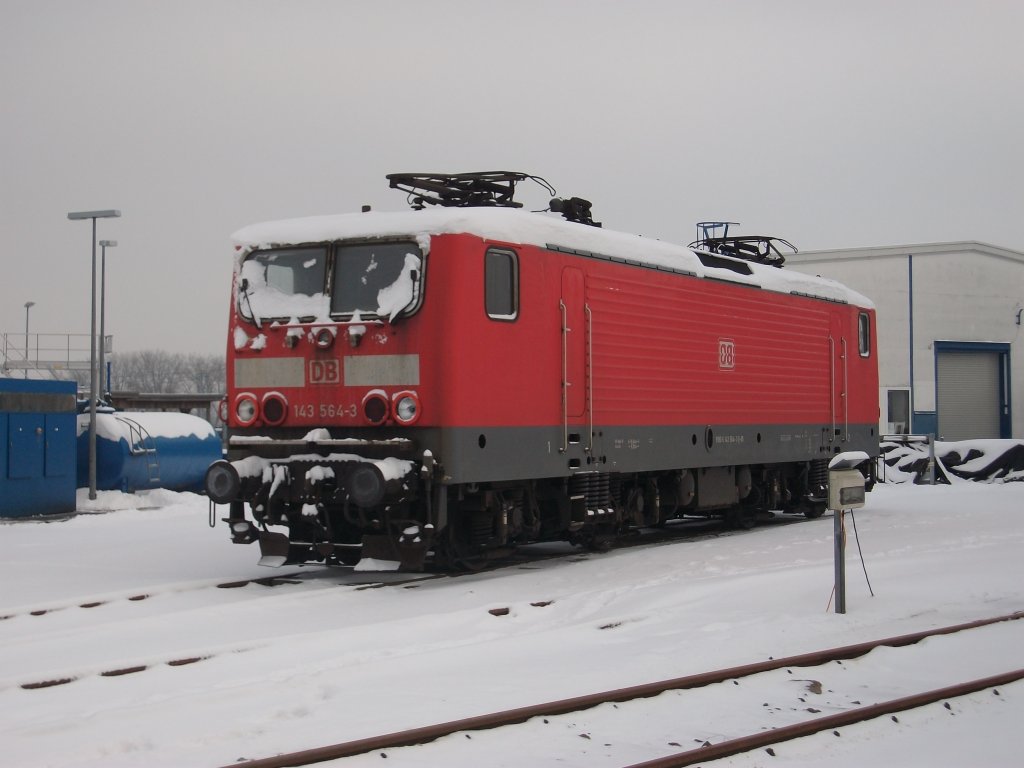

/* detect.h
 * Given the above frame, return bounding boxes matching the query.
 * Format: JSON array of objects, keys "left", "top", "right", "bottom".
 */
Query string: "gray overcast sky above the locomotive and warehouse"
[{"left": 0, "top": 0, "right": 1024, "bottom": 353}]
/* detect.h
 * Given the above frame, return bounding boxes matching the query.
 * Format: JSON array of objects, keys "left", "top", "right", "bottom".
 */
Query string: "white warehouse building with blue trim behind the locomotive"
[{"left": 785, "top": 241, "right": 1024, "bottom": 440}]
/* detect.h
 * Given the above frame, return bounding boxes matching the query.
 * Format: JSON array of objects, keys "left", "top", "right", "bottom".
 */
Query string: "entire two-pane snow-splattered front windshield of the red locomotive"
[{"left": 239, "top": 242, "right": 423, "bottom": 324}]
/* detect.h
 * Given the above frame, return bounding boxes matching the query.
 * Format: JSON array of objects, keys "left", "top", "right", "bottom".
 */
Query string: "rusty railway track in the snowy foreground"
[{"left": 224, "top": 611, "right": 1024, "bottom": 768}]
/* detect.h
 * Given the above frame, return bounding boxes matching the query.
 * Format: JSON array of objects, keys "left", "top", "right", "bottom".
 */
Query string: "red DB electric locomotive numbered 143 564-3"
[{"left": 206, "top": 172, "right": 879, "bottom": 568}]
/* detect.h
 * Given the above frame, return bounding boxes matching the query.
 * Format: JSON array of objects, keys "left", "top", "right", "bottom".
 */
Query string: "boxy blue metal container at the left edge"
[{"left": 0, "top": 379, "right": 76, "bottom": 517}]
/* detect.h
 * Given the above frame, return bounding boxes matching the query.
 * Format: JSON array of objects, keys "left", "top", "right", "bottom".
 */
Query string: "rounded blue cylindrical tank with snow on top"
[{"left": 78, "top": 409, "right": 221, "bottom": 494}]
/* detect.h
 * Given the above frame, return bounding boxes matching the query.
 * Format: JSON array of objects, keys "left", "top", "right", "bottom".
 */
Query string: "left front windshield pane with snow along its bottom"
[{"left": 238, "top": 247, "right": 327, "bottom": 324}]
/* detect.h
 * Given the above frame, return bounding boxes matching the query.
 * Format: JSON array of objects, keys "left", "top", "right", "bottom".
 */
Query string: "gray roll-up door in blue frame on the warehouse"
[{"left": 936, "top": 351, "right": 999, "bottom": 440}]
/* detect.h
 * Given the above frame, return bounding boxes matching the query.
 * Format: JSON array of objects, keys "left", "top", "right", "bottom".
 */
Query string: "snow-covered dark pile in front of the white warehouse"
[{"left": 879, "top": 439, "right": 1024, "bottom": 483}]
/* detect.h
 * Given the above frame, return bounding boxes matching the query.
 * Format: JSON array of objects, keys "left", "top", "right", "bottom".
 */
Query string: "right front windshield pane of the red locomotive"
[{"left": 331, "top": 242, "right": 423, "bottom": 319}]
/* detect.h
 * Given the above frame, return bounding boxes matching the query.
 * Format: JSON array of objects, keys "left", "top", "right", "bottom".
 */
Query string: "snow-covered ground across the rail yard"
[{"left": 0, "top": 482, "right": 1024, "bottom": 768}]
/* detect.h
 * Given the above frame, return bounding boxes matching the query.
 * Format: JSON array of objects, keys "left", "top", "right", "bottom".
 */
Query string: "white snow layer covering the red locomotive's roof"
[{"left": 231, "top": 208, "right": 873, "bottom": 307}]
